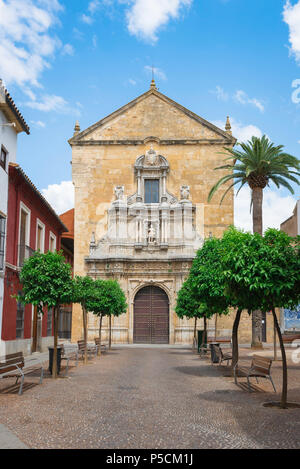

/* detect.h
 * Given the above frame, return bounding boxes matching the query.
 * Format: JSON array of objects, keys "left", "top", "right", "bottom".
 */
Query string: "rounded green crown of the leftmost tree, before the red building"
[{"left": 18, "top": 252, "right": 72, "bottom": 313}]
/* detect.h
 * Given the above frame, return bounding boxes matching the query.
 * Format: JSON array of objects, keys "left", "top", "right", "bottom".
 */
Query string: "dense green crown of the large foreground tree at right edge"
[{"left": 222, "top": 228, "right": 300, "bottom": 311}]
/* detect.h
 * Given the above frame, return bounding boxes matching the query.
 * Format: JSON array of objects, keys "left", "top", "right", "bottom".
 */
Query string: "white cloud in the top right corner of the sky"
[{"left": 283, "top": 0, "right": 300, "bottom": 63}]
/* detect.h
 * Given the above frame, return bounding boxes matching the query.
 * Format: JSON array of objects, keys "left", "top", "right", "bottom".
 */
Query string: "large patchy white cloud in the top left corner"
[{"left": 0, "top": 0, "right": 62, "bottom": 86}]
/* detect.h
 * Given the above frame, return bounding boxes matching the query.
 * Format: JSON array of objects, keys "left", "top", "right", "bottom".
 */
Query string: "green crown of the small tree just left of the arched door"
[{"left": 86, "top": 280, "right": 127, "bottom": 316}]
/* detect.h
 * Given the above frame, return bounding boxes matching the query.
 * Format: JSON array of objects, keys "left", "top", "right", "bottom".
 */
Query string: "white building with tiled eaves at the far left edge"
[{"left": 0, "top": 80, "right": 29, "bottom": 356}]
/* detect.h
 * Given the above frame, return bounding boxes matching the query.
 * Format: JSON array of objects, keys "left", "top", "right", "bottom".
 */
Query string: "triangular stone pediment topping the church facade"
[{"left": 69, "top": 89, "right": 235, "bottom": 145}]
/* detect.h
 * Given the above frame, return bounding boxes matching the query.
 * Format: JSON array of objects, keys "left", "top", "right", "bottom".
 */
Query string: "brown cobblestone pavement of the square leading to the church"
[{"left": 0, "top": 346, "right": 300, "bottom": 449}]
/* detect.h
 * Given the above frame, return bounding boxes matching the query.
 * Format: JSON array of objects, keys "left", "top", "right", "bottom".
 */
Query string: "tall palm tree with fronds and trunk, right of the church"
[{"left": 208, "top": 135, "right": 300, "bottom": 346}]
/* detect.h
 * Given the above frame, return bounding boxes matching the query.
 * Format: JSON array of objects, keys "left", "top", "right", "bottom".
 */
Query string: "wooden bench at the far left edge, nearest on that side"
[{"left": 0, "top": 352, "right": 44, "bottom": 396}]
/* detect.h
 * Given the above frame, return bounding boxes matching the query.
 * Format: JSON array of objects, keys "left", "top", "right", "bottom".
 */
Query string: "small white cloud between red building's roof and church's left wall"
[{"left": 42, "top": 181, "right": 74, "bottom": 214}]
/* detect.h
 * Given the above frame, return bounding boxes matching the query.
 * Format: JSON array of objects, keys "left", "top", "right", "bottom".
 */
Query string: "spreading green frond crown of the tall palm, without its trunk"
[{"left": 208, "top": 135, "right": 300, "bottom": 203}]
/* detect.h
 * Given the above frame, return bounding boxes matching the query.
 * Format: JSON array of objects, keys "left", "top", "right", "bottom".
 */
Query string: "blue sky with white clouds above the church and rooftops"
[{"left": 0, "top": 0, "right": 300, "bottom": 227}]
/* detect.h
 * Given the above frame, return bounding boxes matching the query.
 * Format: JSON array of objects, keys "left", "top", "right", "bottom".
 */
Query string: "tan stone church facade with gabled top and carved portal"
[{"left": 69, "top": 81, "right": 258, "bottom": 344}]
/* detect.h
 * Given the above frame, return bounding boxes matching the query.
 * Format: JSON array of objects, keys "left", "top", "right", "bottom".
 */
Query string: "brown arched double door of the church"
[{"left": 133, "top": 286, "right": 169, "bottom": 344}]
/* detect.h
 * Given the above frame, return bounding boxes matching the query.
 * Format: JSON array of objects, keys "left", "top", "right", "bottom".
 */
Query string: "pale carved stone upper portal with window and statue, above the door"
[{"left": 90, "top": 146, "right": 202, "bottom": 259}]
